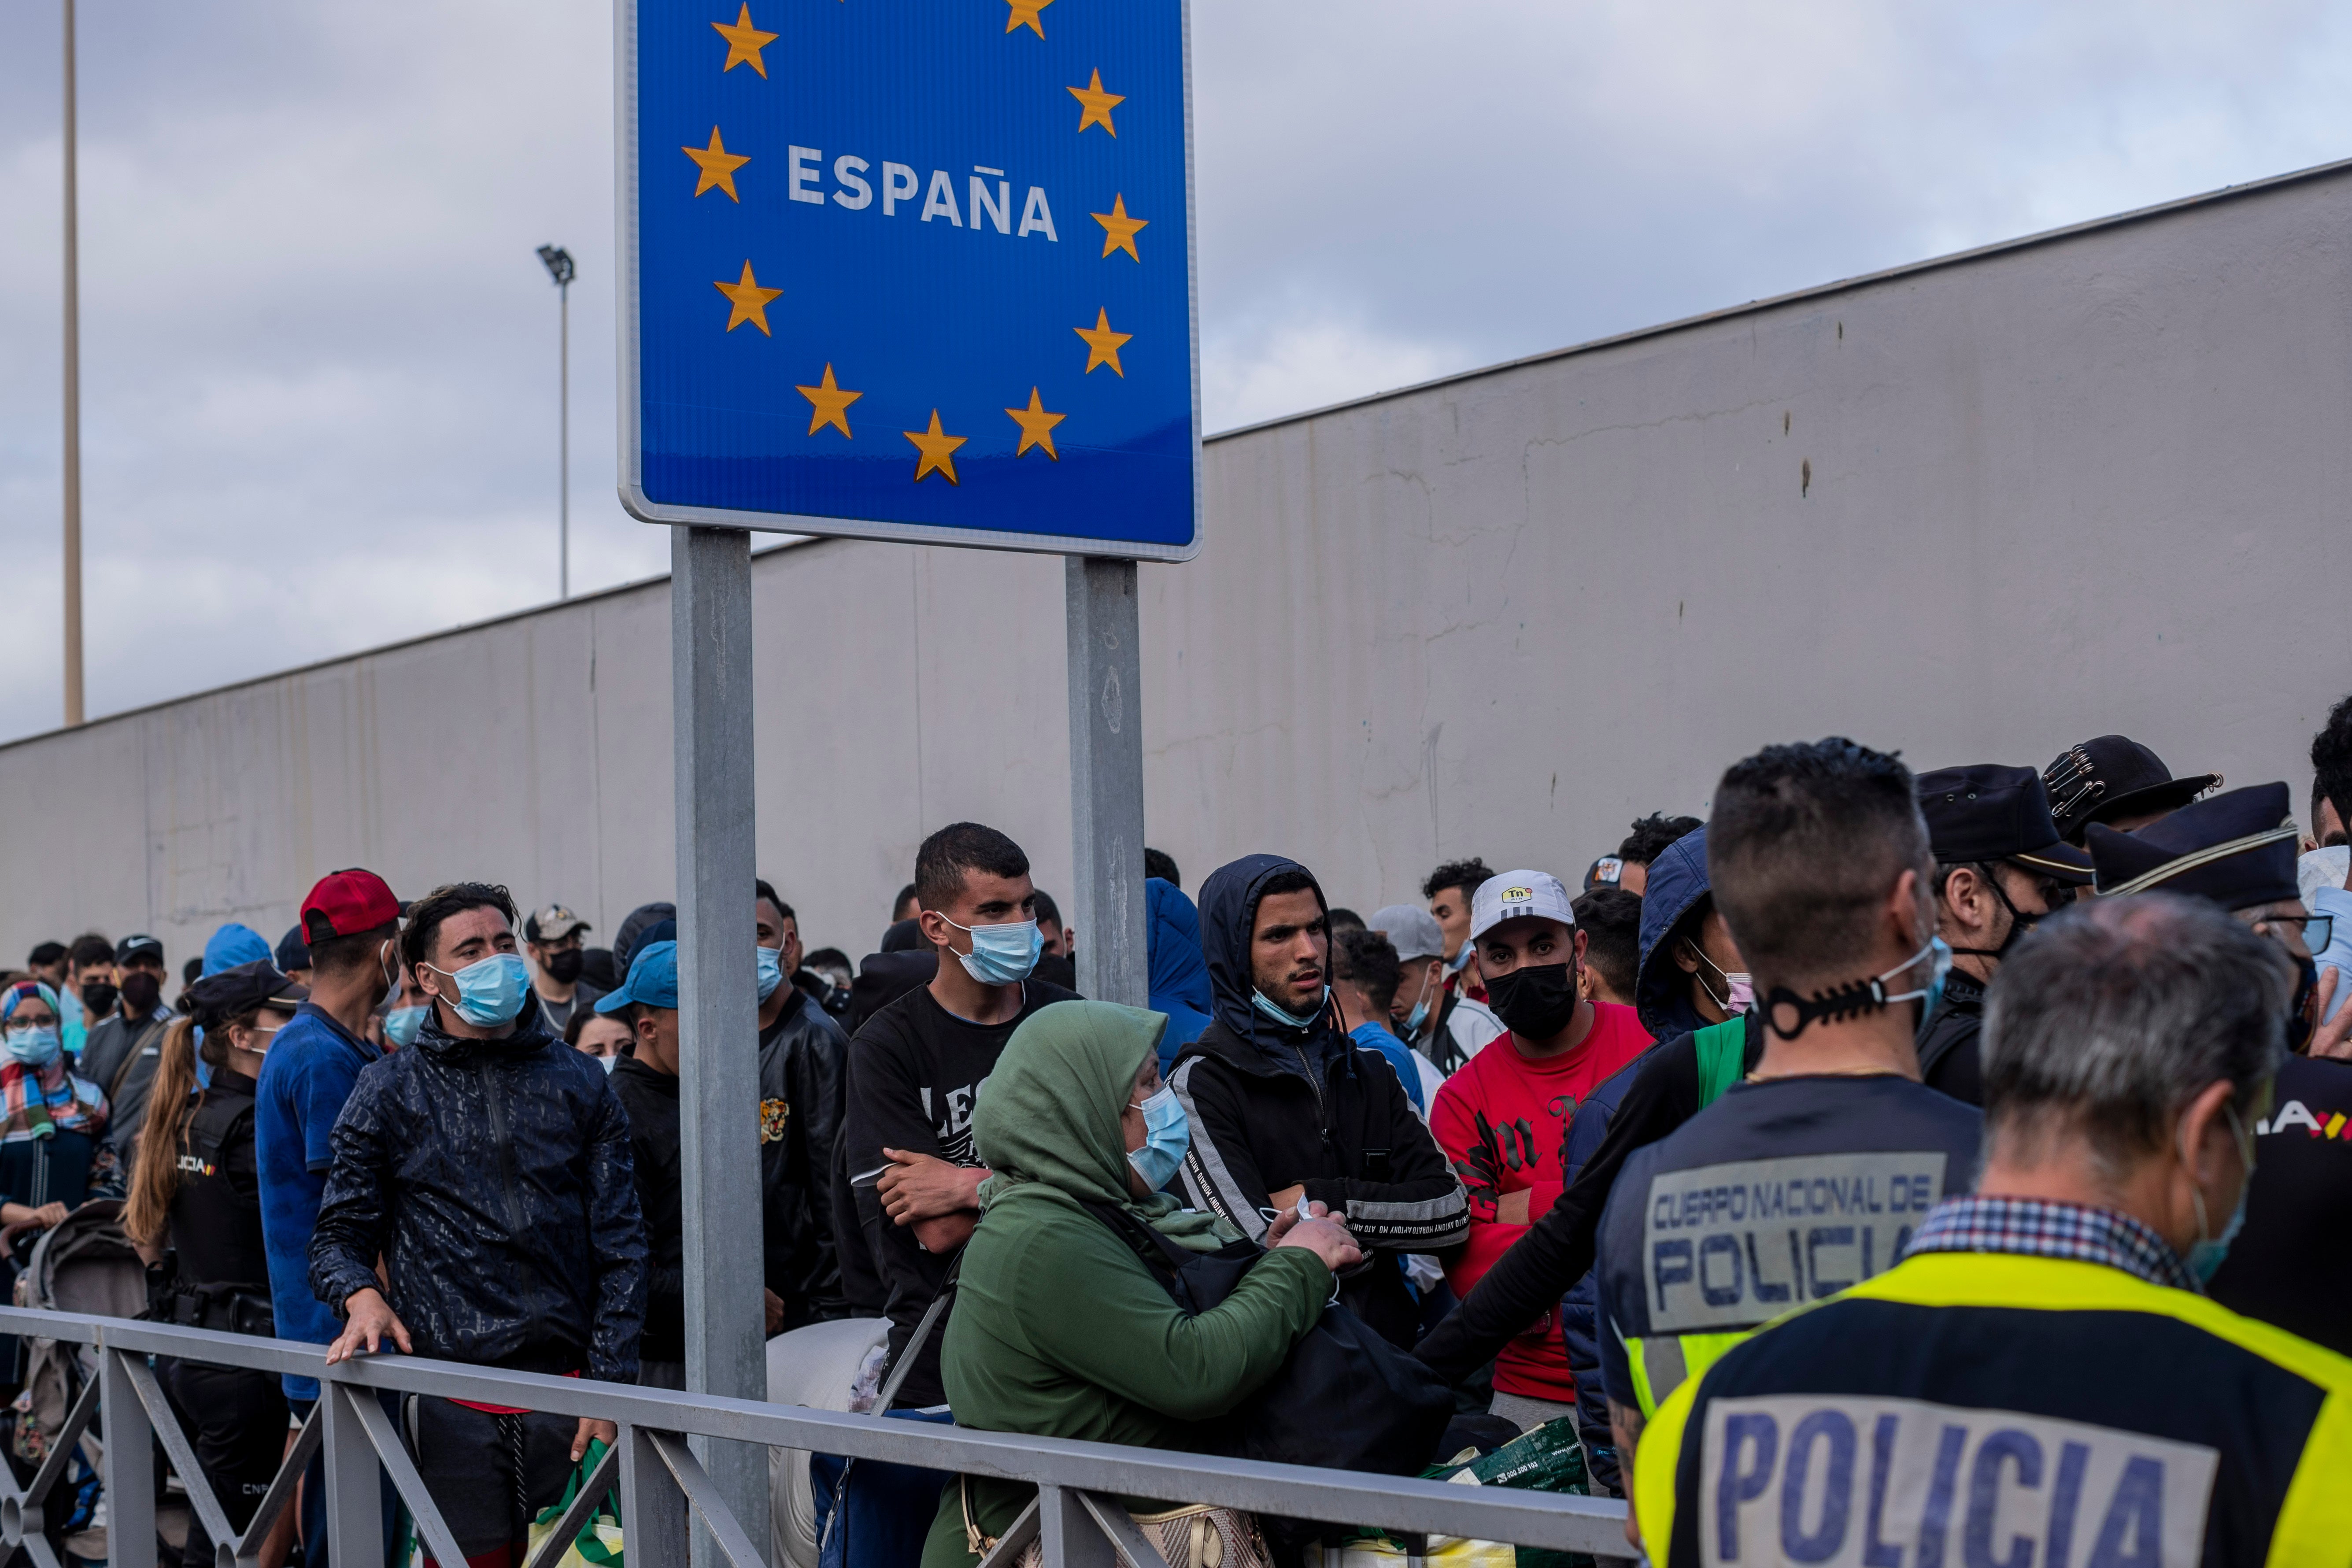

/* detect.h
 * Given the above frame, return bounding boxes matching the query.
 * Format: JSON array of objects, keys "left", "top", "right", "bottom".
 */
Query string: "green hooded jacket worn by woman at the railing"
[{"left": 922, "top": 1002, "right": 1331, "bottom": 1568}]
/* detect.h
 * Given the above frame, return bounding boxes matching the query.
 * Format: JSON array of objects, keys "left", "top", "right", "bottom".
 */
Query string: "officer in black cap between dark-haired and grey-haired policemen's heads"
[{"left": 1919, "top": 762, "right": 2091, "bottom": 1105}]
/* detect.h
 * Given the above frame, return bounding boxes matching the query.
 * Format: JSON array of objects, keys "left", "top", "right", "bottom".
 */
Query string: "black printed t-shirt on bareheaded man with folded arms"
[{"left": 842, "top": 980, "right": 1075, "bottom": 1408}]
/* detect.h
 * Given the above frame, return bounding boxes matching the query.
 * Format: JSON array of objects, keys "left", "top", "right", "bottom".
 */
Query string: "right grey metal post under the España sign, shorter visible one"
[{"left": 1063, "top": 555, "right": 1150, "bottom": 1006}]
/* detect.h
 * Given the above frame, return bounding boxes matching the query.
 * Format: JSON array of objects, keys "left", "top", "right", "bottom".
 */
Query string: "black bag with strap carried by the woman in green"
[{"left": 1087, "top": 1204, "right": 1453, "bottom": 1476}]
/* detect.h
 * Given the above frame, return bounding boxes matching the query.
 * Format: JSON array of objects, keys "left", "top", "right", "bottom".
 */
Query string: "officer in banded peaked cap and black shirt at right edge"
[{"left": 2089, "top": 783, "right": 2352, "bottom": 1354}]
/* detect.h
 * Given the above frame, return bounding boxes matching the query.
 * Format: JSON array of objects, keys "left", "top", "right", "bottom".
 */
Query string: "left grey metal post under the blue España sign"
[{"left": 670, "top": 524, "right": 762, "bottom": 1568}]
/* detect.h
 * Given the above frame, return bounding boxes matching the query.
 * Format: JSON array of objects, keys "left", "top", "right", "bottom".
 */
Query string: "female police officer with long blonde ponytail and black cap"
[{"left": 122, "top": 959, "right": 311, "bottom": 1563}]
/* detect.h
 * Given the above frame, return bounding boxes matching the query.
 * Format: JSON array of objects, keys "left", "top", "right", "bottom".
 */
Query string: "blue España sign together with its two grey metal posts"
[{"left": 614, "top": 0, "right": 1199, "bottom": 1552}]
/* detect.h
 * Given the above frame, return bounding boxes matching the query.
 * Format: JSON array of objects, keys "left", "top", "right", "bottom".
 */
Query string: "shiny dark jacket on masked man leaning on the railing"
[{"left": 311, "top": 997, "right": 644, "bottom": 1382}]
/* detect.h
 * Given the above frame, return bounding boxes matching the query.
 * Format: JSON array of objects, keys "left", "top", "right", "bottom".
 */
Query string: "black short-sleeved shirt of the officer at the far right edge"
[{"left": 2206, "top": 1055, "right": 2352, "bottom": 1357}]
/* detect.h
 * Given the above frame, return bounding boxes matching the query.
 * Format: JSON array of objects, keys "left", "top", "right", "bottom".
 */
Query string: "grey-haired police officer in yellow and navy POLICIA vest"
[{"left": 1635, "top": 893, "right": 2352, "bottom": 1568}]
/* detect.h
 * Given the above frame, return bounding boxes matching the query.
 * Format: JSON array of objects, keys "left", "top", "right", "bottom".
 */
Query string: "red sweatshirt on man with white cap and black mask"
[{"left": 1430, "top": 1002, "right": 1649, "bottom": 1403}]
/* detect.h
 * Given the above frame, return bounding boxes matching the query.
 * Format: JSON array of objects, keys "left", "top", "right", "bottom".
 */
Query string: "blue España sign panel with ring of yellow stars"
[{"left": 616, "top": 0, "right": 1199, "bottom": 559}]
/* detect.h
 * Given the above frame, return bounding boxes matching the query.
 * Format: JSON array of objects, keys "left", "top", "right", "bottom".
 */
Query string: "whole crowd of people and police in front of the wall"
[{"left": 0, "top": 698, "right": 2352, "bottom": 1568}]
